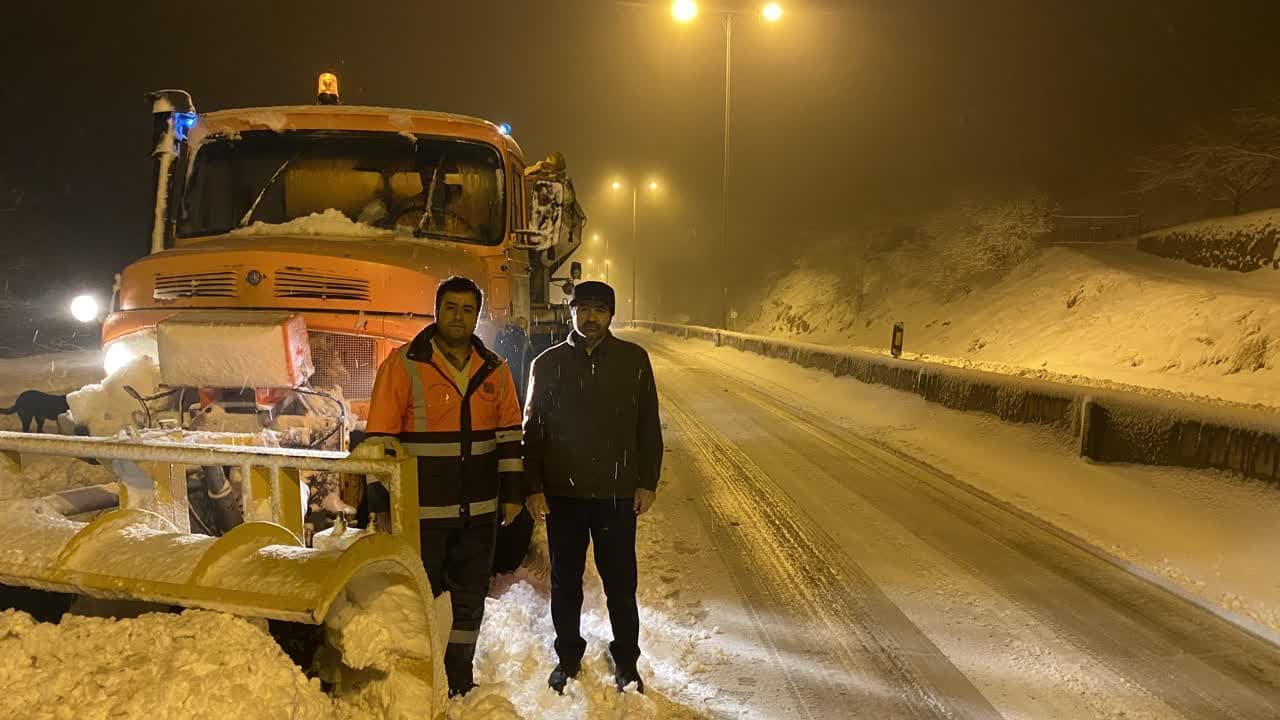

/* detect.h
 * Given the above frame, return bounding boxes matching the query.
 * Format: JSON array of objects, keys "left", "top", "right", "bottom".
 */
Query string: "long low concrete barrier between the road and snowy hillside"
[{"left": 630, "top": 320, "right": 1280, "bottom": 483}]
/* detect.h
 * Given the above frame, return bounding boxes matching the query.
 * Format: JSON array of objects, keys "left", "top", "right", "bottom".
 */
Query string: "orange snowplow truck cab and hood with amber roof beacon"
[{"left": 102, "top": 74, "right": 586, "bottom": 416}]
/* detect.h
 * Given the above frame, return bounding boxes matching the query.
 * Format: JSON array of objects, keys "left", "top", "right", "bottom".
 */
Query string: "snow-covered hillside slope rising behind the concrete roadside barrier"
[{"left": 744, "top": 243, "right": 1280, "bottom": 406}]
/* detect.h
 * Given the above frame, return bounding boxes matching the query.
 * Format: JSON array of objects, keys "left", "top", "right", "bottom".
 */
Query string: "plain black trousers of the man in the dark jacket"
[{"left": 547, "top": 497, "right": 640, "bottom": 670}]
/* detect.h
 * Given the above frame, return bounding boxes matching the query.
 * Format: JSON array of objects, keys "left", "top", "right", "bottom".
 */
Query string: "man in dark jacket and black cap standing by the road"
[{"left": 525, "top": 282, "right": 663, "bottom": 692}]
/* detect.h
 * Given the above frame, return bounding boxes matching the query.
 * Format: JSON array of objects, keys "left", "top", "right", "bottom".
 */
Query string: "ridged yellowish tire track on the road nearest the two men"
[{"left": 663, "top": 395, "right": 1000, "bottom": 719}]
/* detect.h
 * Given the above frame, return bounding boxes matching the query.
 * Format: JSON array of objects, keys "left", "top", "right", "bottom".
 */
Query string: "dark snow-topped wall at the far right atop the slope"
[{"left": 1138, "top": 209, "right": 1280, "bottom": 273}]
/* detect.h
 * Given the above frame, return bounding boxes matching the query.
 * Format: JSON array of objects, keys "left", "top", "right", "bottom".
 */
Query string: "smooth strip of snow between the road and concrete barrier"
[{"left": 646, "top": 334, "right": 1280, "bottom": 635}]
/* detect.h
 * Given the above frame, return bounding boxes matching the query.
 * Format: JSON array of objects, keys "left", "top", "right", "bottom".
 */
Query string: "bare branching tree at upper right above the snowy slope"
[{"left": 1133, "top": 108, "right": 1280, "bottom": 215}]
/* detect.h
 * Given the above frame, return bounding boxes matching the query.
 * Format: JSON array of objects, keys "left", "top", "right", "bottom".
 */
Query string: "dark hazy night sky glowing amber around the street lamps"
[{"left": 0, "top": 0, "right": 1280, "bottom": 313}]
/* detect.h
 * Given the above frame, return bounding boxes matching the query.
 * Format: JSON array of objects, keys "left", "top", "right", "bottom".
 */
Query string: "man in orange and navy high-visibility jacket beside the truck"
[{"left": 365, "top": 277, "right": 524, "bottom": 696}]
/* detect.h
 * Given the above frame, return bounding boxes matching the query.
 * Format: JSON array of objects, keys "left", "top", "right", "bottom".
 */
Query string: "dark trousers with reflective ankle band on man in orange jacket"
[{"left": 420, "top": 519, "right": 498, "bottom": 689}]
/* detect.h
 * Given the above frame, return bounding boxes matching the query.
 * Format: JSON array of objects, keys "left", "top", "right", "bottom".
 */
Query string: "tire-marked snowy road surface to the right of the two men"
[{"left": 634, "top": 332, "right": 1280, "bottom": 720}]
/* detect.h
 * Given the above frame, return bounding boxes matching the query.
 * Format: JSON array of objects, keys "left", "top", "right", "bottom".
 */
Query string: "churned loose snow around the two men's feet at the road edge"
[{"left": 449, "top": 504, "right": 724, "bottom": 720}]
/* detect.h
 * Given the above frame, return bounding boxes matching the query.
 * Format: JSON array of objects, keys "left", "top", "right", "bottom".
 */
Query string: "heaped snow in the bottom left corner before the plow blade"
[{"left": 0, "top": 610, "right": 334, "bottom": 720}]
